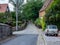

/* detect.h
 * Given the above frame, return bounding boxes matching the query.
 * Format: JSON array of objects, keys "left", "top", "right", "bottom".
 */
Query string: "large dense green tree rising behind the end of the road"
[{"left": 23, "top": 0, "right": 43, "bottom": 20}]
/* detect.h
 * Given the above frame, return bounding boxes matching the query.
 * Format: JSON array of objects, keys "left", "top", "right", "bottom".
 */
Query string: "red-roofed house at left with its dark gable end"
[{"left": 0, "top": 4, "right": 10, "bottom": 19}]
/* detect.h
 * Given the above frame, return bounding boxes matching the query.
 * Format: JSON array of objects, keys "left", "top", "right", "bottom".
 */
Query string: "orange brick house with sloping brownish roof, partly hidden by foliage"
[{"left": 39, "top": 0, "right": 53, "bottom": 17}]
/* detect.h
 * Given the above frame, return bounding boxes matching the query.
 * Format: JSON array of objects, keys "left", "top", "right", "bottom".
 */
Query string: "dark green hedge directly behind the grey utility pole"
[{"left": 11, "top": 12, "right": 26, "bottom": 26}]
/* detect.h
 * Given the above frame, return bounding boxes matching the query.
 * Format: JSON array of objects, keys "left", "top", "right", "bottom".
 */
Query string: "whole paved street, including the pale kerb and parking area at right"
[{"left": 1, "top": 24, "right": 60, "bottom": 45}]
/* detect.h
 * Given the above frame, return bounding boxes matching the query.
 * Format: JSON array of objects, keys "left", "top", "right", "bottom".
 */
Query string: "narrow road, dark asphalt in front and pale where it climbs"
[{"left": 2, "top": 24, "right": 43, "bottom": 45}]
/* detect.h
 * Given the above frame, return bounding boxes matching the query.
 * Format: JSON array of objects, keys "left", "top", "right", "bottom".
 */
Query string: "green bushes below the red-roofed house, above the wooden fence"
[{"left": 0, "top": 12, "right": 11, "bottom": 23}]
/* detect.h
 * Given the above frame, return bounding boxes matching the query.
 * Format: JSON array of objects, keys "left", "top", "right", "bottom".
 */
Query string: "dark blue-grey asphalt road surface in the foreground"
[{"left": 1, "top": 34, "right": 38, "bottom": 45}]
